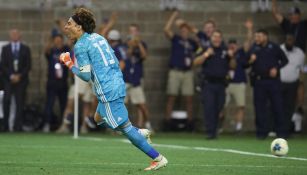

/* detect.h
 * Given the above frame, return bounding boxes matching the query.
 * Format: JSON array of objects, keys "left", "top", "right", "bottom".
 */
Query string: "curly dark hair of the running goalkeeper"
[{"left": 72, "top": 8, "right": 96, "bottom": 33}]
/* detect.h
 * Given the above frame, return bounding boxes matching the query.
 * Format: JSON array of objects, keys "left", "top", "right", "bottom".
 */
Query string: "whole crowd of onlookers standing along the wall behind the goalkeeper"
[{"left": 0, "top": 0, "right": 307, "bottom": 139}]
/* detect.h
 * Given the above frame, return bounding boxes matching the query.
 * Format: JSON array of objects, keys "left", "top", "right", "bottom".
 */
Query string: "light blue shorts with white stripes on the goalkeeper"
[{"left": 96, "top": 98, "right": 128, "bottom": 129}]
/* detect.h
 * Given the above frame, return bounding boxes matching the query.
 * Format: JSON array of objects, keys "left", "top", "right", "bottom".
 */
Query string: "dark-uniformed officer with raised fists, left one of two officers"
[{"left": 193, "top": 30, "right": 236, "bottom": 139}]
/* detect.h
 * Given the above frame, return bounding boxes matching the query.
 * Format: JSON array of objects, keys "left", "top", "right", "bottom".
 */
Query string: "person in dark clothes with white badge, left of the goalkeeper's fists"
[{"left": 43, "top": 34, "right": 70, "bottom": 132}]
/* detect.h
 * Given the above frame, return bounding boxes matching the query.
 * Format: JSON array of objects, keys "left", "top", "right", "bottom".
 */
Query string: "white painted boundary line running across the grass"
[{"left": 80, "top": 137, "right": 307, "bottom": 161}]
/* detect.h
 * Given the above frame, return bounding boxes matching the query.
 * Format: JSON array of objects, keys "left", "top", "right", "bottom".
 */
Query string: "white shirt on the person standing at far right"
[{"left": 280, "top": 44, "right": 305, "bottom": 83}]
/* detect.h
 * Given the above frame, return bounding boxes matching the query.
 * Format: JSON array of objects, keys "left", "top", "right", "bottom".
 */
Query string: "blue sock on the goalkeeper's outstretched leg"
[{"left": 121, "top": 125, "right": 159, "bottom": 159}]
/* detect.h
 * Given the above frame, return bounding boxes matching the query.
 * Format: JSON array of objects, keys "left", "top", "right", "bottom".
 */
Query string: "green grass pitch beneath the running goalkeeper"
[{"left": 0, "top": 133, "right": 307, "bottom": 175}]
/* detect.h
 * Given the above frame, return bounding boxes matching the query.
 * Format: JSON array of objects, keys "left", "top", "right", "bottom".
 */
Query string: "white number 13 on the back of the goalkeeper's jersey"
[{"left": 94, "top": 41, "right": 115, "bottom": 66}]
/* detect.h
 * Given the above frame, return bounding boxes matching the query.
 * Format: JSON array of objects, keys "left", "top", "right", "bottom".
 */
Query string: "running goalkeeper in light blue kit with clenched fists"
[{"left": 60, "top": 8, "right": 167, "bottom": 170}]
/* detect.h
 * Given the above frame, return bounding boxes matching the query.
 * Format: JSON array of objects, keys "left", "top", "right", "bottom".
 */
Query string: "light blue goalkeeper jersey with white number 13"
[{"left": 72, "top": 33, "right": 126, "bottom": 103}]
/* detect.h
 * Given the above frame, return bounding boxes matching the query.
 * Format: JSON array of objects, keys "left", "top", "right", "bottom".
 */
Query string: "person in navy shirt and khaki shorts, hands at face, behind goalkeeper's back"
[{"left": 124, "top": 24, "right": 152, "bottom": 130}]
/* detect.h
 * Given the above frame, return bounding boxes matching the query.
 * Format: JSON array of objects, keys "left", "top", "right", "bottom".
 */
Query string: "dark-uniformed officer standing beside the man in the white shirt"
[{"left": 249, "top": 29, "right": 288, "bottom": 139}]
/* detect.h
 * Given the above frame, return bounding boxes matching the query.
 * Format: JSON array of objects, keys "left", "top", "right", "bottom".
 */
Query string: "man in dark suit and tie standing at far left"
[{"left": 0, "top": 29, "right": 31, "bottom": 131}]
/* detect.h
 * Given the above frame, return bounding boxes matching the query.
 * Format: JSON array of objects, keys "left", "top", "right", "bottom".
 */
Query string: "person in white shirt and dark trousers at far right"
[{"left": 280, "top": 34, "right": 305, "bottom": 132}]
